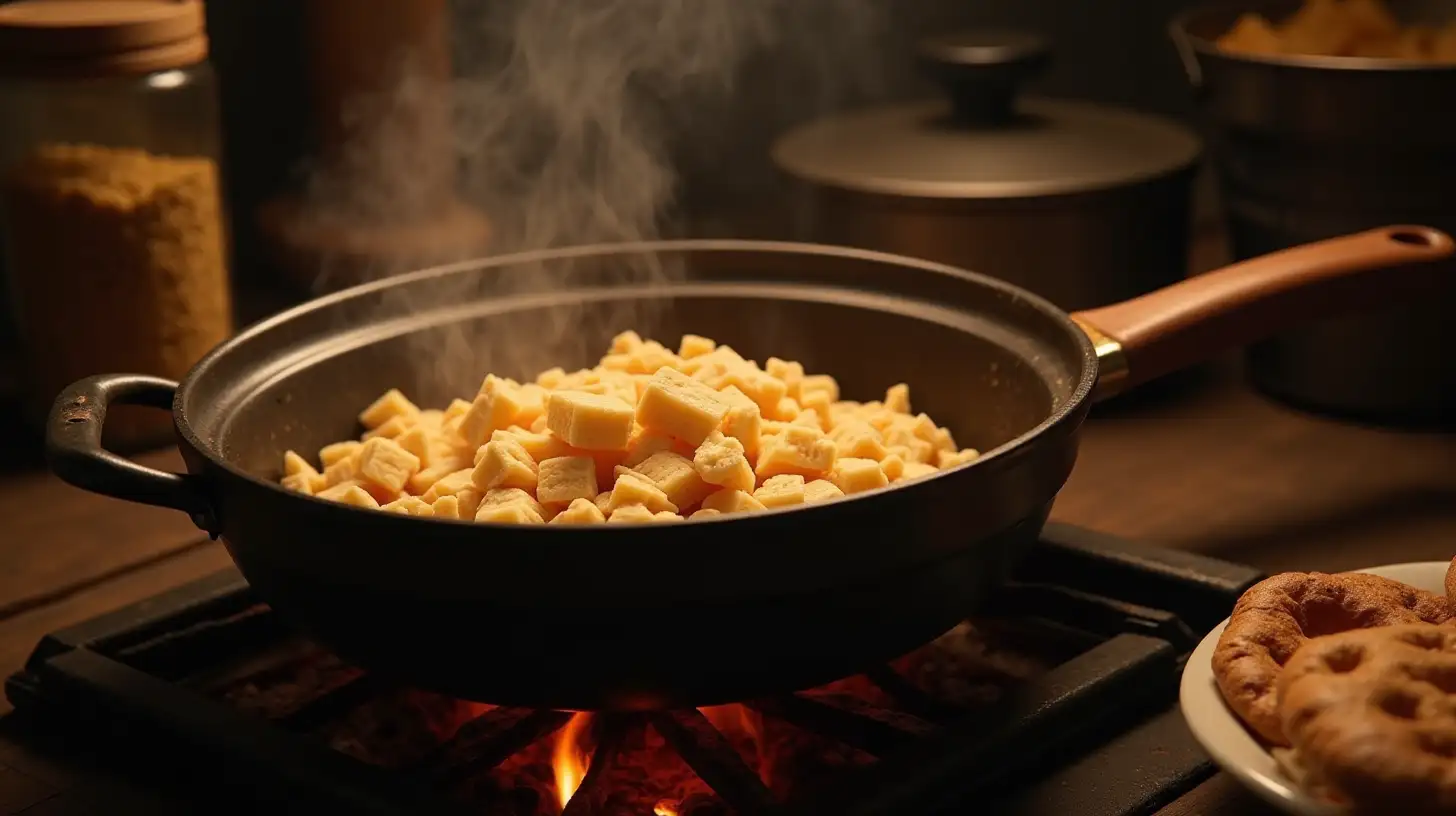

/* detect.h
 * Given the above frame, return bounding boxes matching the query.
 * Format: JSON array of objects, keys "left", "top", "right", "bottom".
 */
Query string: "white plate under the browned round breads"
[{"left": 1178, "top": 561, "right": 1450, "bottom": 816}]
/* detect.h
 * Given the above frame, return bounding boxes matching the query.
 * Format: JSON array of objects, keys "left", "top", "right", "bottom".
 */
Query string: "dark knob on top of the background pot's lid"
[{"left": 916, "top": 29, "right": 1051, "bottom": 124}]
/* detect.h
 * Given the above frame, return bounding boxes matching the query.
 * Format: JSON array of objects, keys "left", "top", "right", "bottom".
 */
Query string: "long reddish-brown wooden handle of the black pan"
[{"left": 1072, "top": 226, "right": 1456, "bottom": 396}]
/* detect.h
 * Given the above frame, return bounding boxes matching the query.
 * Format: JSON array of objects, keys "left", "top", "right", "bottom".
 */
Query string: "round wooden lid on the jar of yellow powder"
[{"left": 0, "top": 0, "right": 207, "bottom": 79}]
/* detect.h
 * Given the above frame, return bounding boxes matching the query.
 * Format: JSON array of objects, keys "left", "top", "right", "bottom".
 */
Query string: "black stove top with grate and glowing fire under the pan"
[{"left": 6, "top": 525, "right": 1261, "bottom": 816}]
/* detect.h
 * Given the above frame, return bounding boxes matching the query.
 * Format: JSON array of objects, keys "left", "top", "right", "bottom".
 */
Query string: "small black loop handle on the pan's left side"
[{"left": 45, "top": 374, "right": 217, "bottom": 536}]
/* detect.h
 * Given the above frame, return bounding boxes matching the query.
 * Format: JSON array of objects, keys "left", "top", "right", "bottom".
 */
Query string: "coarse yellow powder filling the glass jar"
[{"left": 0, "top": 144, "right": 232, "bottom": 437}]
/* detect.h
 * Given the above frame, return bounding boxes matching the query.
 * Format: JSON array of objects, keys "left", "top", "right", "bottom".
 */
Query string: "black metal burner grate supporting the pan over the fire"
[{"left": 6, "top": 525, "right": 1259, "bottom": 816}]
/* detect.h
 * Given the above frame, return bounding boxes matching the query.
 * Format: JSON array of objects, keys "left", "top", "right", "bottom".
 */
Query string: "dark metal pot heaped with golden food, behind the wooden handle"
[{"left": 1172, "top": 0, "right": 1456, "bottom": 427}]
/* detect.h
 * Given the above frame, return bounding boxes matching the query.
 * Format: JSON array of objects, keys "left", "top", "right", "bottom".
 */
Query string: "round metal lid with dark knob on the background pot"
[{"left": 773, "top": 31, "right": 1200, "bottom": 198}]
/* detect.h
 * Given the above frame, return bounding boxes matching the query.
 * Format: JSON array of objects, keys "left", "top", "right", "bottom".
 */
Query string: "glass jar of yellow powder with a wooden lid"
[{"left": 0, "top": 0, "right": 232, "bottom": 447}]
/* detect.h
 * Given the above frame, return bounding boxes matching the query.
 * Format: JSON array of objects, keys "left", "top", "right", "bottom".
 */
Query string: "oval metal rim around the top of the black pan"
[{"left": 172, "top": 239, "right": 1099, "bottom": 536}]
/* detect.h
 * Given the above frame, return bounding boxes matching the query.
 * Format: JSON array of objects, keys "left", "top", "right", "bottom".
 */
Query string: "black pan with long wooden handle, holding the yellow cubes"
[{"left": 48, "top": 226, "right": 1453, "bottom": 710}]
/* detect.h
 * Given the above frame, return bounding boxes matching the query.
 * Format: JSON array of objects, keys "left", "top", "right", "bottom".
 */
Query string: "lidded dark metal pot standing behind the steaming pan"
[{"left": 773, "top": 31, "right": 1200, "bottom": 310}]
